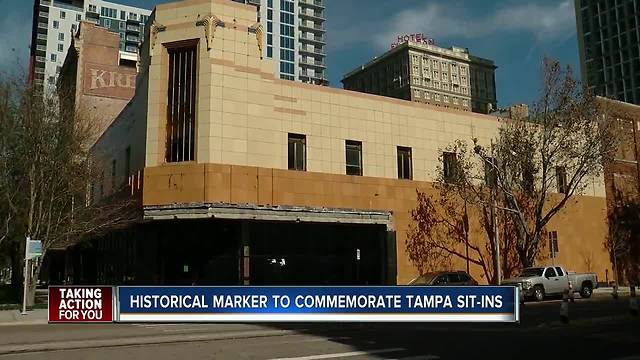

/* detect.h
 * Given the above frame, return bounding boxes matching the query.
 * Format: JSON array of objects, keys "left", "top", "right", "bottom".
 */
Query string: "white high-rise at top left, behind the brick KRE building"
[{"left": 29, "top": 0, "right": 151, "bottom": 88}]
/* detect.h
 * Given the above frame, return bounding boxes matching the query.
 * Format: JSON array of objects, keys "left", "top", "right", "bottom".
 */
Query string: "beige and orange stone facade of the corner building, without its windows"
[{"left": 96, "top": 0, "right": 610, "bottom": 283}]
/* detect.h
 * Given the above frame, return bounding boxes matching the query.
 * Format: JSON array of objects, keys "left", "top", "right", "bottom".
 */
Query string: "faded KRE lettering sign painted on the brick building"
[{"left": 83, "top": 63, "right": 136, "bottom": 99}]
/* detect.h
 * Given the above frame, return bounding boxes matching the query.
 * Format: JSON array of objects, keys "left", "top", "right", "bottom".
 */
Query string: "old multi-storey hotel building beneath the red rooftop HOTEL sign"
[{"left": 342, "top": 36, "right": 497, "bottom": 114}]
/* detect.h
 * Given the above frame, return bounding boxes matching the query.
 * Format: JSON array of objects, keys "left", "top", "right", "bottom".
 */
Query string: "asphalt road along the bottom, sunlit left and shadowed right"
[{"left": 0, "top": 299, "right": 640, "bottom": 360}]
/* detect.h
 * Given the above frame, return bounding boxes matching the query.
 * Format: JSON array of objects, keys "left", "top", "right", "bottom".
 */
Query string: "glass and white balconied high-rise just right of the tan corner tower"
[{"left": 234, "top": 0, "right": 329, "bottom": 85}]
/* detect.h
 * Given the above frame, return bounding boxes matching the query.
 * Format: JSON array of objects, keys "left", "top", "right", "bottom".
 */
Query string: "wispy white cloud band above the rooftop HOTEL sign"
[{"left": 330, "top": 0, "right": 575, "bottom": 49}]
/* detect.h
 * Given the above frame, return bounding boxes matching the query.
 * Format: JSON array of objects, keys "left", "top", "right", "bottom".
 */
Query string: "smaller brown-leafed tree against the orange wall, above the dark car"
[{"left": 406, "top": 141, "right": 519, "bottom": 283}]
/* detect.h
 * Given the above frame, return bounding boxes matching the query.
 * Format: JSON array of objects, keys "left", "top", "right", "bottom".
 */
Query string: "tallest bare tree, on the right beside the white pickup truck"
[{"left": 475, "top": 59, "right": 617, "bottom": 267}]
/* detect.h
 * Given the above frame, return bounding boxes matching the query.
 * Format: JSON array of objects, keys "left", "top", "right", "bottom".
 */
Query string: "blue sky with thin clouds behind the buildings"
[{"left": 0, "top": 0, "right": 579, "bottom": 107}]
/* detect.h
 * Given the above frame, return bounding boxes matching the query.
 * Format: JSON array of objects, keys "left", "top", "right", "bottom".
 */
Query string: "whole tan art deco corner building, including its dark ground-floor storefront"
[{"left": 81, "top": 0, "right": 611, "bottom": 284}]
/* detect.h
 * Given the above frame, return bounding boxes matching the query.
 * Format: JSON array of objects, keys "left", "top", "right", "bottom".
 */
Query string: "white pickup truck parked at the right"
[{"left": 502, "top": 266, "right": 598, "bottom": 301}]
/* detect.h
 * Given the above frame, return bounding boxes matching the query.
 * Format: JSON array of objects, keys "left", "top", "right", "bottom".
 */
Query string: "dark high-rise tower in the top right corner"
[{"left": 575, "top": 0, "right": 640, "bottom": 104}]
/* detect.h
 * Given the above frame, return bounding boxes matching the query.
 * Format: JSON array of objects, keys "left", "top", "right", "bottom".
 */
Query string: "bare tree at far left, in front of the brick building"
[{"left": 0, "top": 77, "right": 139, "bottom": 306}]
